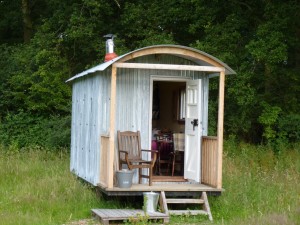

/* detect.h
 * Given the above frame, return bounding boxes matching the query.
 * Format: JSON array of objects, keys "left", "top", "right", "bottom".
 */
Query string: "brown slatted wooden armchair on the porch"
[{"left": 118, "top": 131, "right": 157, "bottom": 185}]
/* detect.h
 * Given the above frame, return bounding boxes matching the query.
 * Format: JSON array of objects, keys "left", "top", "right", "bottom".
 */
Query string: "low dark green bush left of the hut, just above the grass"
[{"left": 0, "top": 111, "right": 71, "bottom": 148}]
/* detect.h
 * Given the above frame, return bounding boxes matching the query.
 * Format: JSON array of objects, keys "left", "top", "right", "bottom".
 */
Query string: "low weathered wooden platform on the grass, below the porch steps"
[{"left": 92, "top": 209, "right": 169, "bottom": 225}]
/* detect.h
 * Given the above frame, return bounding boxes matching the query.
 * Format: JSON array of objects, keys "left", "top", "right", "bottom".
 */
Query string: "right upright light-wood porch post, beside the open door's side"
[{"left": 217, "top": 71, "right": 225, "bottom": 188}]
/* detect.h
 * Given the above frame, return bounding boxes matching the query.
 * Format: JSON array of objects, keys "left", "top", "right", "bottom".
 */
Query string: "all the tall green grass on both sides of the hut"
[{"left": 0, "top": 142, "right": 300, "bottom": 225}]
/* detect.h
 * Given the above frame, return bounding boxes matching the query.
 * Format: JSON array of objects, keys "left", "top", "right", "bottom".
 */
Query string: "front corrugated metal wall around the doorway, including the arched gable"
[{"left": 116, "top": 55, "right": 208, "bottom": 183}]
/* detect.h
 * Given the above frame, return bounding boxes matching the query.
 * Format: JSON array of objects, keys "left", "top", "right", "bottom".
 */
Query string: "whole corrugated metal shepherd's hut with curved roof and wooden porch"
[{"left": 67, "top": 37, "right": 235, "bottom": 198}]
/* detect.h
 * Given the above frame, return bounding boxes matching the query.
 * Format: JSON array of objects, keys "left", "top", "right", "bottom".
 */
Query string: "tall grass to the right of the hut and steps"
[{"left": 211, "top": 141, "right": 300, "bottom": 224}]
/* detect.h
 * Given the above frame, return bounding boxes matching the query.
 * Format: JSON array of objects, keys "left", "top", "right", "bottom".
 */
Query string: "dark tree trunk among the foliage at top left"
[{"left": 22, "top": 0, "right": 33, "bottom": 43}]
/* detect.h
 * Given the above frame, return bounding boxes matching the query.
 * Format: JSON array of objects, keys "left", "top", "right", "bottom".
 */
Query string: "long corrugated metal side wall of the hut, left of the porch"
[{"left": 70, "top": 70, "right": 111, "bottom": 185}]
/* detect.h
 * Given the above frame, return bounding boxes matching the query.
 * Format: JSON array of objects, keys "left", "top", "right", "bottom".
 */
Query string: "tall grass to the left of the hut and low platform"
[{"left": 0, "top": 147, "right": 119, "bottom": 225}]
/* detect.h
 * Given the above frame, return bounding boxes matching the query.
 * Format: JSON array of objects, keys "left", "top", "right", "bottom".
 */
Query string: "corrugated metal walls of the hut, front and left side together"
[{"left": 70, "top": 55, "right": 208, "bottom": 185}]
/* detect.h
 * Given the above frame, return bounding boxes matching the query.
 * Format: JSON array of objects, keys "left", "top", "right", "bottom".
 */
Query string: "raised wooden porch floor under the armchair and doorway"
[{"left": 98, "top": 178, "right": 224, "bottom": 196}]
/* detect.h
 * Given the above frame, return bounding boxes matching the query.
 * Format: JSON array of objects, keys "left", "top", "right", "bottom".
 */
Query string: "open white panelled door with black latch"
[{"left": 184, "top": 80, "right": 202, "bottom": 182}]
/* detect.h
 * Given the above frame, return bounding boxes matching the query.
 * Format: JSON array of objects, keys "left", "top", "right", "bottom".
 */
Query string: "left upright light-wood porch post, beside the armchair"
[{"left": 107, "top": 65, "right": 117, "bottom": 188}]
